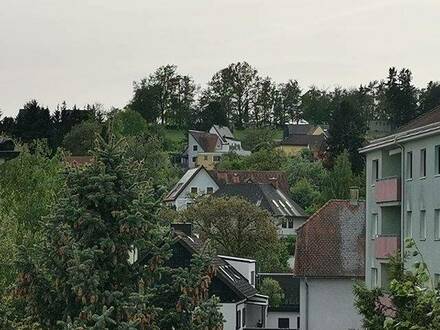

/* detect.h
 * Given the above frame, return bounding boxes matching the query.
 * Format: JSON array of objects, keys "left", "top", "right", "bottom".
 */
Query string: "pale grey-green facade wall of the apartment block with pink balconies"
[{"left": 365, "top": 136, "right": 440, "bottom": 287}]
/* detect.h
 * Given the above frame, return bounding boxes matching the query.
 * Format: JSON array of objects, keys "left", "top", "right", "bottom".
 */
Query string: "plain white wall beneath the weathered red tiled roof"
[{"left": 300, "top": 278, "right": 362, "bottom": 330}]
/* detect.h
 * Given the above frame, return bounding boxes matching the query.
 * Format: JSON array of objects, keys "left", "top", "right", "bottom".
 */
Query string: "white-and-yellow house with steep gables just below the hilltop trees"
[{"left": 182, "top": 125, "right": 250, "bottom": 170}]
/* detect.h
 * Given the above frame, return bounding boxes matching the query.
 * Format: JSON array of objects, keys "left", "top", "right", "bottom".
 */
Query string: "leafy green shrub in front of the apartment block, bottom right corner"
[{"left": 354, "top": 239, "right": 440, "bottom": 330}]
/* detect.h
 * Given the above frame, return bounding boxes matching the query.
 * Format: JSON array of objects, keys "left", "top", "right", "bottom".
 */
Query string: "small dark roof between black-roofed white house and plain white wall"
[{"left": 258, "top": 273, "right": 300, "bottom": 312}]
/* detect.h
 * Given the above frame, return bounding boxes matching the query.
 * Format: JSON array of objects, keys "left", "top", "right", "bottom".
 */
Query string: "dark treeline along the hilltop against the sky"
[{"left": 0, "top": 62, "right": 440, "bottom": 146}]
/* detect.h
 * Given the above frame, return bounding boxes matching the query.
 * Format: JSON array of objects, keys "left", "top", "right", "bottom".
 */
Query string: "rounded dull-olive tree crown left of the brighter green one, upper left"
[{"left": 63, "top": 120, "right": 101, "bottom": 156}]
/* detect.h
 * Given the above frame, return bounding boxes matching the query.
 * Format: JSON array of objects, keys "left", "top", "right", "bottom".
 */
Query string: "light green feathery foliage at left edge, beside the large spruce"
[{"left": 0, "top": 142, "right": 64, "bottom": 296}]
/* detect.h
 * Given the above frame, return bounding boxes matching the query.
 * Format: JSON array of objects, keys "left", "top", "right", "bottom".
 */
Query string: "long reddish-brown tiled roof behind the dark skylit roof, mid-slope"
[{"left": 210, "top": 170, "right": 289, "bottom": 193}]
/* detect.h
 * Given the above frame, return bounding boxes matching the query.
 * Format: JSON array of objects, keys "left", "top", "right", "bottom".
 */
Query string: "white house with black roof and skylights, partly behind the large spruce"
[{"left": 170, "top": 224, "right": 268, "bottom": 330}]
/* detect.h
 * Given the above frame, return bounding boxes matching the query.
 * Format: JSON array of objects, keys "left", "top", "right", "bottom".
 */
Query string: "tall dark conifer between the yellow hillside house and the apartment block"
[{"left": 327, "top": 95, "right": 367, "bottom": 173}]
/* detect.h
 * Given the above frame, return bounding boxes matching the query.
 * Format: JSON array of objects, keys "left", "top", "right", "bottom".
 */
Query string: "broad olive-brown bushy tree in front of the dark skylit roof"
[{"left": 181, "top": 197, "right": 288, "bottom": 271}]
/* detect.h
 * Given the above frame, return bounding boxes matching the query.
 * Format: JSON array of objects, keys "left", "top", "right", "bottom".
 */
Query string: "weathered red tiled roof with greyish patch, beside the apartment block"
[{"left": 294, "top": 200, "right": 365, "bottom": 277}]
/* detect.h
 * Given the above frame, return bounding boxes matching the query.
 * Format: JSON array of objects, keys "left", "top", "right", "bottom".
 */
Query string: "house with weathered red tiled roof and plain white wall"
[{"left": 294, "top": 200, "right": 366, "bottom": 330}]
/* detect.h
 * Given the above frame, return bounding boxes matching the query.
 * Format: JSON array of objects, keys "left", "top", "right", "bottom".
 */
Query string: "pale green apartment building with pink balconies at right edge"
[{"left": 360, "top": 107, "right": 440, "bottom": 288}]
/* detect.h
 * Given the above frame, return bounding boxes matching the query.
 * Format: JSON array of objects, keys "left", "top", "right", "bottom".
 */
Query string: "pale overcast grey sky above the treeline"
[{"left": 0, "top": 0, "right": 440, "bottom": 115}]
